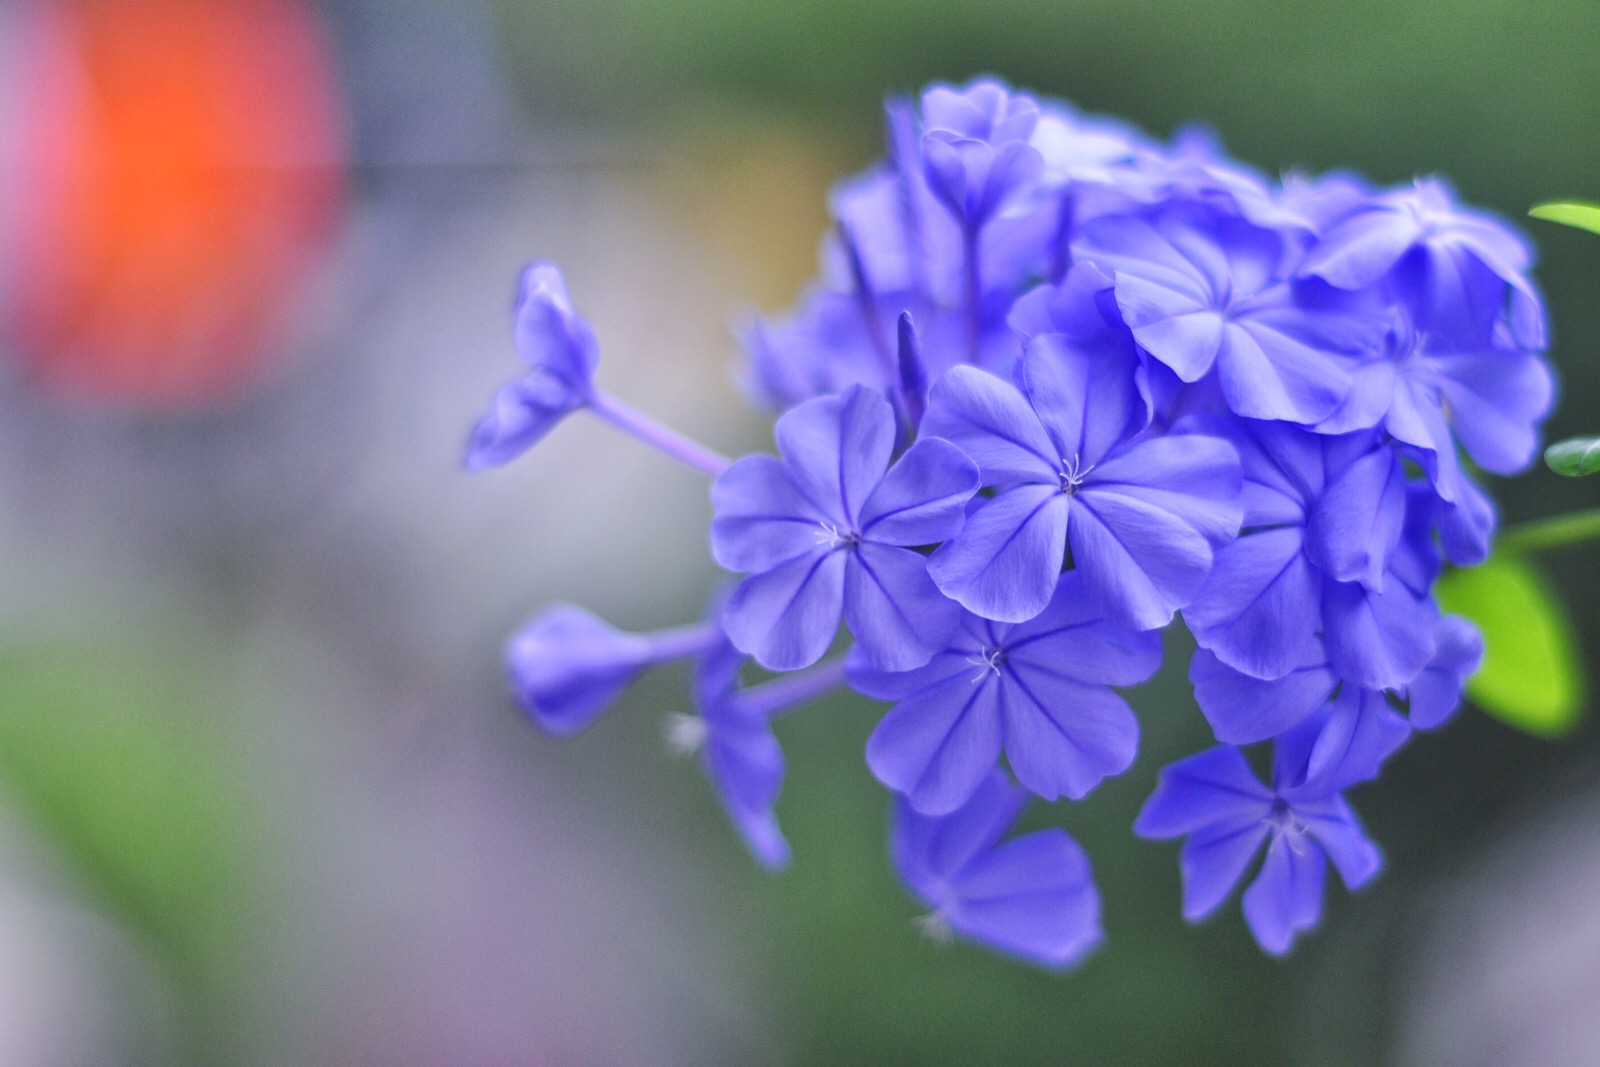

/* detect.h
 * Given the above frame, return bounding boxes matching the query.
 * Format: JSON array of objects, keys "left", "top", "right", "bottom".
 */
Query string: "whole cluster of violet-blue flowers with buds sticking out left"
[{"left": 469, "top": 80, "right": 1552, "bottom": 966}]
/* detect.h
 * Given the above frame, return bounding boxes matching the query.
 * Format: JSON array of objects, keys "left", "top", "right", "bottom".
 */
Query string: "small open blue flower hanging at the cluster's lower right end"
[{"left": 1133, "top": 745, "right": 1382, "bottom": 955}]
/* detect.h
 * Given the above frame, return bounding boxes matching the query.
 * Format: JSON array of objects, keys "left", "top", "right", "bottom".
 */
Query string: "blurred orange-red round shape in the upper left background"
[{"left": 0, "top": 0, "right": 344, "bottom": 408}]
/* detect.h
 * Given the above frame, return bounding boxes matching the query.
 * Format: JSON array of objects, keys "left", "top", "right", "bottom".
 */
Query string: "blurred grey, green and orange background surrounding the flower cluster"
[{"left": 0, "top": 0, "right": 1600, "bottom": 1067}]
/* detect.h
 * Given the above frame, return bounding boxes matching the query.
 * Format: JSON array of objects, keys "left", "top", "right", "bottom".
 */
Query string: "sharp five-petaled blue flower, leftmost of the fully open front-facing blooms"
[{"left": 710, "top": 387, "right": 978, "bottom": 670}]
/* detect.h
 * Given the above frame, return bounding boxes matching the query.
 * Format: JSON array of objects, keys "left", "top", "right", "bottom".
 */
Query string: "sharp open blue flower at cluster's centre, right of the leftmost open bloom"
[{"left": 922, "top": 272, "right": 1238, "bottom": 630}]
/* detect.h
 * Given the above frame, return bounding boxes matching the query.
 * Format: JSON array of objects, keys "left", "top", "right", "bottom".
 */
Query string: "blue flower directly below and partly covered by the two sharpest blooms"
[{"left": 848, "top": 571, "right": 1162, "bottom": 814}]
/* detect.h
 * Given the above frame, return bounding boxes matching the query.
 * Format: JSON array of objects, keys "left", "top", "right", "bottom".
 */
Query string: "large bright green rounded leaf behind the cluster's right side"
[{"left": 1435, "top": 557, "right": 1584, "bottom": 737}]
